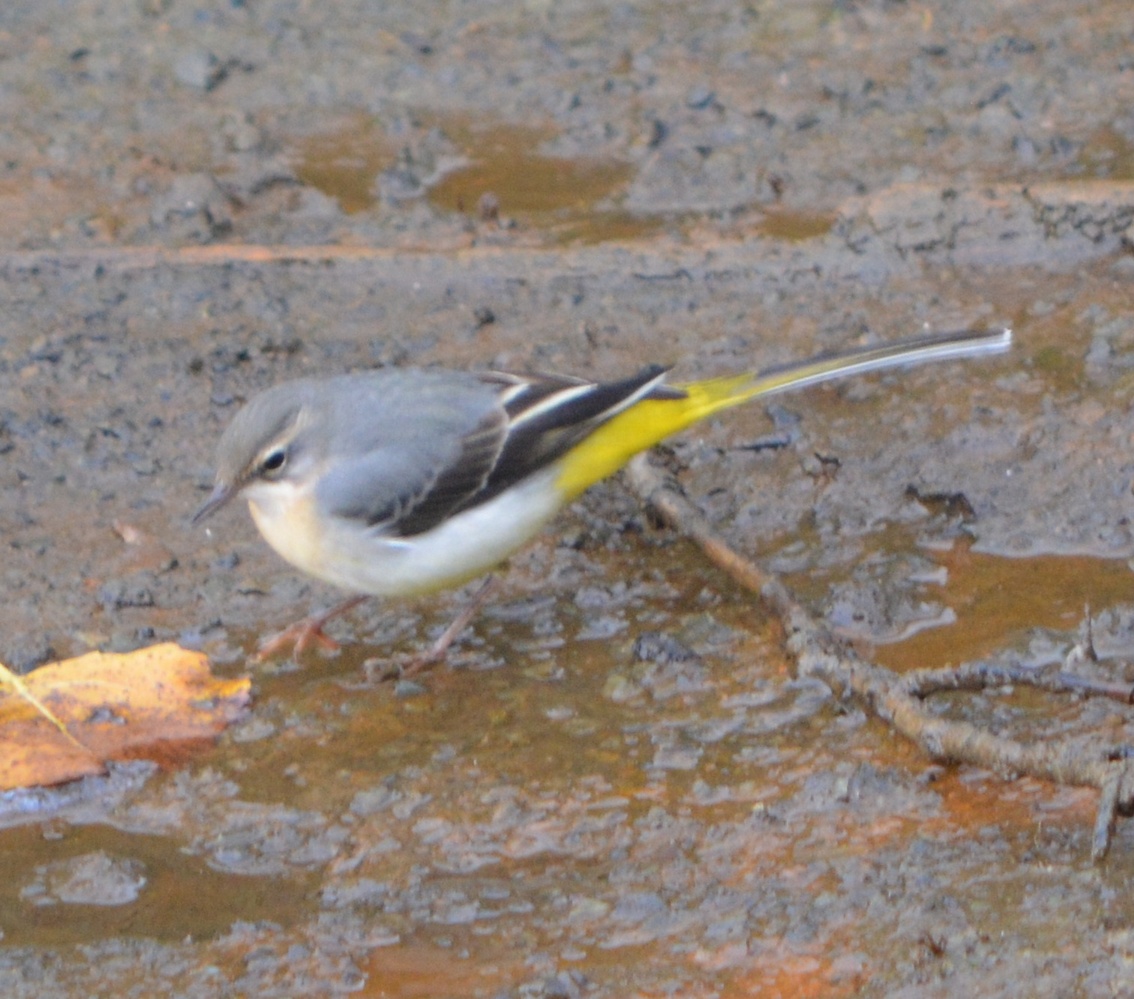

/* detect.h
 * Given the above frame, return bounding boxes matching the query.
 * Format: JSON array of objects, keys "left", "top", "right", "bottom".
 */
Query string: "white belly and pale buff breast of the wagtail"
[{"left": 248, "top": 466, "right": 564, "bottom": 596}]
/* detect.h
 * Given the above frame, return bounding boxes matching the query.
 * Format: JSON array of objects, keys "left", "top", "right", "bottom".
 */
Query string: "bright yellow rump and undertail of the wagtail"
[{"left": 556, "top": 374, "right": 757, "bottom": 499}]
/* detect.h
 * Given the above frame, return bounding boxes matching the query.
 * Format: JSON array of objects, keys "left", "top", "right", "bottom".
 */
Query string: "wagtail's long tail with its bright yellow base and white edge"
[{"left": 558, "top": 329, "right": 1012, "bottom": 497}]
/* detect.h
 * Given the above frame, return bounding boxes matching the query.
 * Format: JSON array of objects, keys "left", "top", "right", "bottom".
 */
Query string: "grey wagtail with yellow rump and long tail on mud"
[{"left": 193, "top": 329, "right": 1012, "bottom": 661}]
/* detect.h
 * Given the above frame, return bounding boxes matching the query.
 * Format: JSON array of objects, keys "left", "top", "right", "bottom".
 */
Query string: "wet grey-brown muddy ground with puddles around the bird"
[{"left": 0, "top": 0, "right": 1134, "bottom": 997}]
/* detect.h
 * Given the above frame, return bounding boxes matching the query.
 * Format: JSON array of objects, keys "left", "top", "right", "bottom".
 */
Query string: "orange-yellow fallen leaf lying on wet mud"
[{"left": 0, "top": 643, "right": 251, "bottom": 790}]
